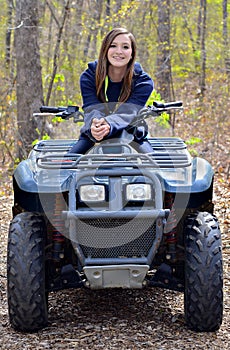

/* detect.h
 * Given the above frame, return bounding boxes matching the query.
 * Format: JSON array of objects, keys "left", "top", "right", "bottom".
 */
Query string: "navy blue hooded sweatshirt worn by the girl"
[{"left": 80, "top": 60, "right": 154, "bottom": 141}]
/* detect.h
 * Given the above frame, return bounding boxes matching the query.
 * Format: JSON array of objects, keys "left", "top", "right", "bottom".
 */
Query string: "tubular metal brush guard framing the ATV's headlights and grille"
[{"left": 63, "top": 166, "right": 170, "bottom": 266}]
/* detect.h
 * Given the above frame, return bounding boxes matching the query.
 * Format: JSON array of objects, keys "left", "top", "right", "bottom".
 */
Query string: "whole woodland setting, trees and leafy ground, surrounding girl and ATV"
[{"left": 0, "top": 0, "right": 230, "bottom": 350}]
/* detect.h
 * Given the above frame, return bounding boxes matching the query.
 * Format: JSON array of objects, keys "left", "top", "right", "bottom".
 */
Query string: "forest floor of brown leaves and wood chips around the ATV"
[{"left": 0, "top": 104, "right": 230, "bottom": 350}]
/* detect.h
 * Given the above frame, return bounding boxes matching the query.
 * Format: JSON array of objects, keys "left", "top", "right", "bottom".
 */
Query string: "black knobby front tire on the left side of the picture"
[{"left": 7, "top": 213, "right": 48, "bottom": 331}]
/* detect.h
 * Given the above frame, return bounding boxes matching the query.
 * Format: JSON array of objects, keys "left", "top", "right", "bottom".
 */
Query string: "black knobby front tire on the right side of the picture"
[{"left": 184, "top": 212, "right": 223, "bottom": 332}]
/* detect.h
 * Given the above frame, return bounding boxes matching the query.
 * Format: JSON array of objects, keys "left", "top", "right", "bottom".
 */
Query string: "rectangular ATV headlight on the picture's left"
[{"left": 80, "top": 185, "right": 105, "bottom": 202}]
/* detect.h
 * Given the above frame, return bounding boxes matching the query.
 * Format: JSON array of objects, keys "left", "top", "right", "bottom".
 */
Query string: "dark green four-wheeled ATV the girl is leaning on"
[{"left": 7, "top": 102, "right": 223, "bottom": 332}]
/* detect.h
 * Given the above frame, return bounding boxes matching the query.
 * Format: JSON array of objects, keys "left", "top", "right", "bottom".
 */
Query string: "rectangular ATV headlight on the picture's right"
[{"left": 126, "top": 184, "right": 152, "bottom": 201}]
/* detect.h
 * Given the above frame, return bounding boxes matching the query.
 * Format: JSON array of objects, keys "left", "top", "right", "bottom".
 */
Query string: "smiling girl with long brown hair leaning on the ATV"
[{"left": 69, "top": 28, "right": 154, "bottom": 154}]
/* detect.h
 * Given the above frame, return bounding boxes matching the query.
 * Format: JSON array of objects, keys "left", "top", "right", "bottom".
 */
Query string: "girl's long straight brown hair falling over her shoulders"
[{"left": 96, "top": 28, "right": 136, "bottom": 102}]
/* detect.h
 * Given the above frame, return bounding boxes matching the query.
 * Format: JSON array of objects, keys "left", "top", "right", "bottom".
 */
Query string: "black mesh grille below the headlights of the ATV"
[{"left": 77, "top": 218, "right": 156, "bottom": 258}]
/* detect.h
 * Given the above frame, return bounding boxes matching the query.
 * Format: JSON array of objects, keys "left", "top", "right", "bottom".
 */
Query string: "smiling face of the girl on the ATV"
[{"left": 107, "top": 34, "right": 132, "bottom": 68}]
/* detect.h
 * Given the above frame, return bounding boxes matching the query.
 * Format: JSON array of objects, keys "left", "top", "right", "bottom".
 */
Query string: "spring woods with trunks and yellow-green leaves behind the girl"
[{"left": 0, "top": 0, "right": 230, "bottom": 171}]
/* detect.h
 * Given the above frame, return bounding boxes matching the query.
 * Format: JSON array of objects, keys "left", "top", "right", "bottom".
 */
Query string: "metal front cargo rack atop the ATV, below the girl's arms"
[{"left": 34, "top": 138, "right": 191, "bottom": 169}]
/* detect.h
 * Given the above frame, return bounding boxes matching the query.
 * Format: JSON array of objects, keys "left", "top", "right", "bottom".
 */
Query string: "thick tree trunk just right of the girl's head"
[{"left": 156, "top": 0, "right": 171, "bottom": 101}]
